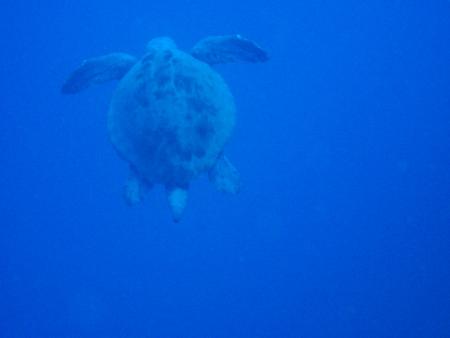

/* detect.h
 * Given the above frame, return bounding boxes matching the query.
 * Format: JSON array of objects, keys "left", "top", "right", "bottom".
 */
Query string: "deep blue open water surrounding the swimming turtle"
[{"left": 0, "top": 0, "right": 450, "bottom": 338}]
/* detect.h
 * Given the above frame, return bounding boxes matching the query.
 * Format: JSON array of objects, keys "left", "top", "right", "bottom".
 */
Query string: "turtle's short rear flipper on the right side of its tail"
[{"left": 208, "top": 155, "right": 240, "bottom": 194}]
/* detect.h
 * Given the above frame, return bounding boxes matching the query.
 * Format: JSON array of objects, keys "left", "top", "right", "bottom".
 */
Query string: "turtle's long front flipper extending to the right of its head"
[{"left": 191, "top": 35, "right": 269, "bottom": 65}]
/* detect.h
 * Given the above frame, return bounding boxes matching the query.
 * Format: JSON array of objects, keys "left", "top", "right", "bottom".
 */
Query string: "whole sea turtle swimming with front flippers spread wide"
[{"left": 62, "top": 35, "right": 268, "bottom": 221}]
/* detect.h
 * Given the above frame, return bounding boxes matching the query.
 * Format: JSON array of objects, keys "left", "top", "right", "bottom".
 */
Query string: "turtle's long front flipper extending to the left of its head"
[{"left": 61, "top": 53, "right": 137, "bottom": 94}]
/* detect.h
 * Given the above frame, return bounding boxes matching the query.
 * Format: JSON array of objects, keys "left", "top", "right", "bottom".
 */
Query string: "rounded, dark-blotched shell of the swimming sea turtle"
[{"left": 108, "top": 39, "right": 235, "bottom": 188}]
